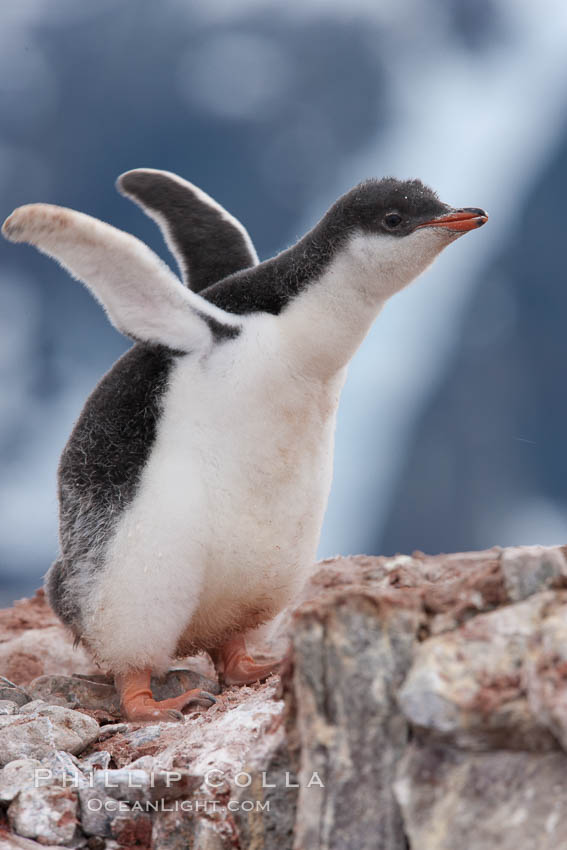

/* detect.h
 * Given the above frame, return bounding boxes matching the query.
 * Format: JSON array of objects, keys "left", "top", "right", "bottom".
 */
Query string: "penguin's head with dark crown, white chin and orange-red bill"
[{"left": 323, "top": 177, "right": 488, "bottom": 298}]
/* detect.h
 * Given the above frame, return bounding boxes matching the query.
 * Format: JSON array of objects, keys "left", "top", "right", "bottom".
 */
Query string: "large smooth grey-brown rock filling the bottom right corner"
[{"left": 394, "top": 744, "right": 567, "bottom": 850}]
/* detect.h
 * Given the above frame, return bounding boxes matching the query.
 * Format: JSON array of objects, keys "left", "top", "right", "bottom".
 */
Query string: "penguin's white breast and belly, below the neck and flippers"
[{"left": 82, "top": 315, "right": 344, "bottom": 671}]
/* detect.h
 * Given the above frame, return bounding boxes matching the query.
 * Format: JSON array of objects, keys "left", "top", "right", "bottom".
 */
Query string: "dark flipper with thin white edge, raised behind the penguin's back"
[{"left": 116, "top": 168, "right": 258, "bottom": 292}]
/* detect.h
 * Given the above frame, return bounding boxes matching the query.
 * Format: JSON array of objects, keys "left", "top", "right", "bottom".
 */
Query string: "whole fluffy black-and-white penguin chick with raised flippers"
[{"left": 3, "top": 171, "right": 487, "bottom": 720}]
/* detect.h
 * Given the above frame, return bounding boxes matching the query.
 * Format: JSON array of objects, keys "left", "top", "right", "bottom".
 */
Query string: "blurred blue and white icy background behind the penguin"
[{"left": 0, "top": 0, "right": 567, "bottom": 603}]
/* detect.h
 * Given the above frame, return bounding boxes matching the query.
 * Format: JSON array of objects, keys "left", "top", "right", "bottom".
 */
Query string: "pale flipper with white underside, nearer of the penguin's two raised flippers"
[{"left": 2, "top": 204, "right": 239, "bottom": 352}]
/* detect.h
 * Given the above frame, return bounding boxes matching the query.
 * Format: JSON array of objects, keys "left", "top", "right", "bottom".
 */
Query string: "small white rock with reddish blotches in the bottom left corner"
[{"left": 8, "top": 785, "right": 78, "bottom": 844}]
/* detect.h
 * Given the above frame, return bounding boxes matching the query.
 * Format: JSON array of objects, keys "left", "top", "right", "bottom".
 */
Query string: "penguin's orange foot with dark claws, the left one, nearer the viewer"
[{"left": 115, "top": 670, "right": 216, "bottom": 723}]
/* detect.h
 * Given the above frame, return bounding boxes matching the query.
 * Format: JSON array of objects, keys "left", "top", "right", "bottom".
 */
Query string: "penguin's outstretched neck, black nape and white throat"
[{"left": 202, "top": 217, "right": 438, "bottom": 380}]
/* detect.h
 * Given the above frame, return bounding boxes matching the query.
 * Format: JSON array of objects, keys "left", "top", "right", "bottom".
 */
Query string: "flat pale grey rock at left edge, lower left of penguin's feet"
[{"left": 0, "top": 705, "right": 99, "bottom": 765}]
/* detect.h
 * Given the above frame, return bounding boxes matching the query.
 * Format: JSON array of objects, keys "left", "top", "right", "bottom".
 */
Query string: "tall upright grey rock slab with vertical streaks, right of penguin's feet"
[{"left": 288, "top": 588, "right": 419, "bottom": 850}]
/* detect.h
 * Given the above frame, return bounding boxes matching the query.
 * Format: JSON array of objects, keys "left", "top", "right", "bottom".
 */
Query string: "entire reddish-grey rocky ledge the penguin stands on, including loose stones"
[{"left": 0, "top": 547, "right": 567, "bottom": 850}]
